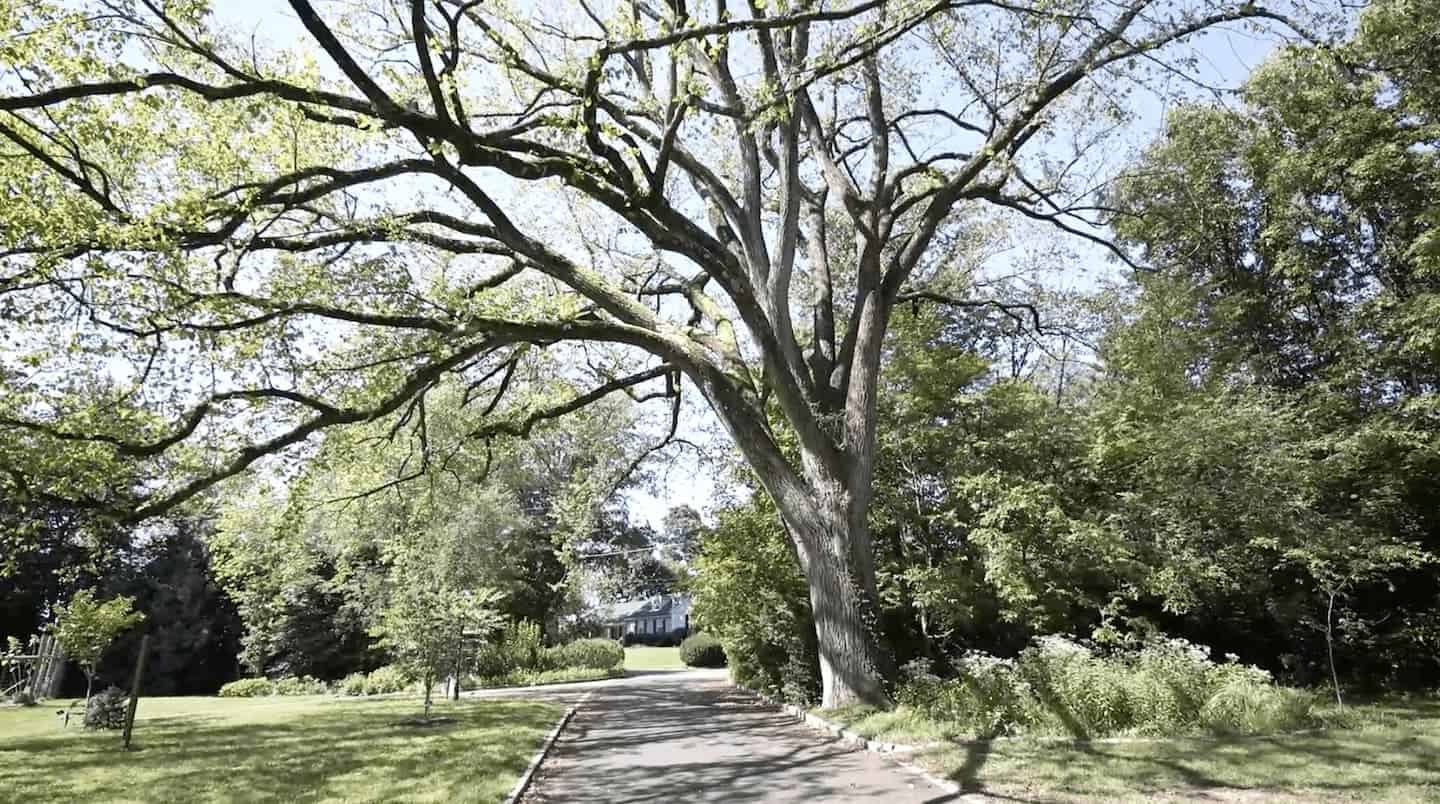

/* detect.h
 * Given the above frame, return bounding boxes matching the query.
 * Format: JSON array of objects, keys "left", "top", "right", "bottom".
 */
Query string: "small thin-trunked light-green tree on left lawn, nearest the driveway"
[{"left": 376, "top": 568, "right": 504, "bottom": 718}]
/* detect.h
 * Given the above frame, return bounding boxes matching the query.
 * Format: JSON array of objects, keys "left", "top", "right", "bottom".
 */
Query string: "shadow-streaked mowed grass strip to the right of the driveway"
[{"left": 824, "top": 699, "right": 1440, "bottom": 804}]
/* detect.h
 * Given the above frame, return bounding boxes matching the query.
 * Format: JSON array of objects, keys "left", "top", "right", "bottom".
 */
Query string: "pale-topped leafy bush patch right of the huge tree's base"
[{"left": 897, "top": 637, "right": 1315, "bottom": 738}]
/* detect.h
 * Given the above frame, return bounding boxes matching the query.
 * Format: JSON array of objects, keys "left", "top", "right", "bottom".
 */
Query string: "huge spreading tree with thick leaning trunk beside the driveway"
[{"left": 0, "top": 0, "right": 1324, "bottom": 706}]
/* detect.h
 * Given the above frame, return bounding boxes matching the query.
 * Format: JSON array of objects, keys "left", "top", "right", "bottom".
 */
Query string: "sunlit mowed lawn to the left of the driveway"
[{"left": 0, "top": 696, "right": 562, "bottom": 801}]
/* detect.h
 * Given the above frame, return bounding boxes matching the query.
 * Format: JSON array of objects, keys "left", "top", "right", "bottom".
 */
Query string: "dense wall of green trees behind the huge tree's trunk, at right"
[{"left": 697, "top": 0, "right": 1440, "bottom": 706}]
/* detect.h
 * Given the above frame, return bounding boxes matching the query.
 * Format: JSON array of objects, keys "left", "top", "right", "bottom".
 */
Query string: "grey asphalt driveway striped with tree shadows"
[{"left": 524, "top": 670, "right": 955, "bottom": 804}]
